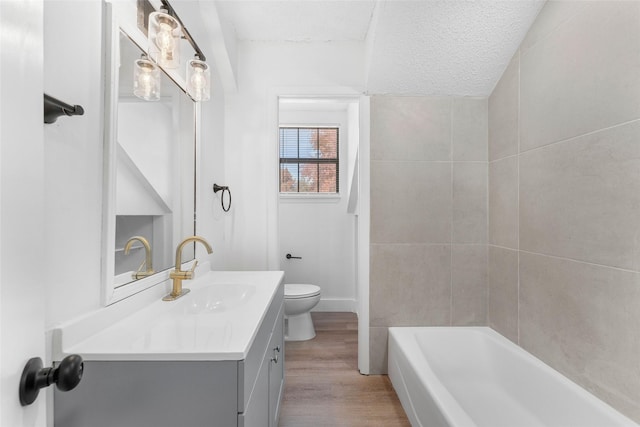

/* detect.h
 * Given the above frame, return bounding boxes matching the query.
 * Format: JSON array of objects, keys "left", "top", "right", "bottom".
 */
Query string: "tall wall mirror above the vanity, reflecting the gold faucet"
[{"left": 104, "top": 23, "right": 196, "bottom": 304}]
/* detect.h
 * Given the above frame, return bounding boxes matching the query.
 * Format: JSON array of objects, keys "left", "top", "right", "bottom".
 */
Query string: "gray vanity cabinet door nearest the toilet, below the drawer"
[{"left": 269, "top": 310, "right": 284, "bottom": 427}]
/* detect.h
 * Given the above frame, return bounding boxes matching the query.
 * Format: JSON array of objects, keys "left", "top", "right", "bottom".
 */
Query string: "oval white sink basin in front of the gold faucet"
[{"left": 182, "top": 283, "right": 256, "bottom": 314}]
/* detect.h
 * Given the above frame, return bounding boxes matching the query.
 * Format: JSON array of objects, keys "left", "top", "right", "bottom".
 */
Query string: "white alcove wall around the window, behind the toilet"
[{"left": 278, "top": 108, "right": 358, "bottom": 311}]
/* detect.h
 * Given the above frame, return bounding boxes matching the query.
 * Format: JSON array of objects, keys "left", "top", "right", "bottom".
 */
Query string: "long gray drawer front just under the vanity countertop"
[{"left": 238, "top": 282, "right": 284, "bottom": 413}]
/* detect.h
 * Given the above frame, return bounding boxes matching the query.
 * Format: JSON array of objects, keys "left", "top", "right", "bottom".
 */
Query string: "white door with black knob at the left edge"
[{"left": 0, "top": 0, "right": 48, "bottom": 427}]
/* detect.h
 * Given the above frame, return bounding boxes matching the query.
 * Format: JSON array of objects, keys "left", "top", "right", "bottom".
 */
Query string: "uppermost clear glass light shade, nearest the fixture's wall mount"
[{"left": 149, "top": 12, "right": 182, "bottom": 68}]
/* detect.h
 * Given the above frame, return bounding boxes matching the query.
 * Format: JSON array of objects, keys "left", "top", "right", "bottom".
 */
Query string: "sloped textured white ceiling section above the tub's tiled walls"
[{"left": 367, "top": 0, "right": 544, "bottom": 96}]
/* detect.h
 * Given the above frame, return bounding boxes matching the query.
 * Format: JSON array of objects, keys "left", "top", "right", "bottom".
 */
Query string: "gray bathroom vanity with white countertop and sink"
[{"left": 53, "top": 272, "right": 284, "bottom": 427}]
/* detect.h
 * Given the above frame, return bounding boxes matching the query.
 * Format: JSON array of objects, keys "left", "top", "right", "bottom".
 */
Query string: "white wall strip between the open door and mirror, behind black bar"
[{"left": 43, "top": 1, "right": 104, "bottom": 326}]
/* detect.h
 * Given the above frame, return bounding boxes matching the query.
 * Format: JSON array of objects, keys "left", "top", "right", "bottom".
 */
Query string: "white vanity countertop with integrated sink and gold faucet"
[{"left": 53, "top": 271, "right": 284, "bottom": 360}]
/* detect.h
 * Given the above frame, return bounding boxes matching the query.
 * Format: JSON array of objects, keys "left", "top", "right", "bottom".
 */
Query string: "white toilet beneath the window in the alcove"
[{"left": 284, "top": 284, "right": 320, "bottom": 341}]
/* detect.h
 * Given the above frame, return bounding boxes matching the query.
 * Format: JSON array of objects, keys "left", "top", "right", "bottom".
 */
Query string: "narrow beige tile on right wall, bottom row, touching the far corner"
[{"left": 488, "top": 246, "right": 518, "bottom": 343}]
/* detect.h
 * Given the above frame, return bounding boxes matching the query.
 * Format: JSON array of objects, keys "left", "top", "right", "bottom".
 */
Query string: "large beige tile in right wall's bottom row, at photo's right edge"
[{"left": 520, "top": 253, "right": 640, "bottom": 420}]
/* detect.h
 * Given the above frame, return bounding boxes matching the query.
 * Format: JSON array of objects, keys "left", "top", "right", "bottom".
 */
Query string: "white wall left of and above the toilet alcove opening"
[{"left": 225, "top": 42, "right": 363, "bottom": 270}]
